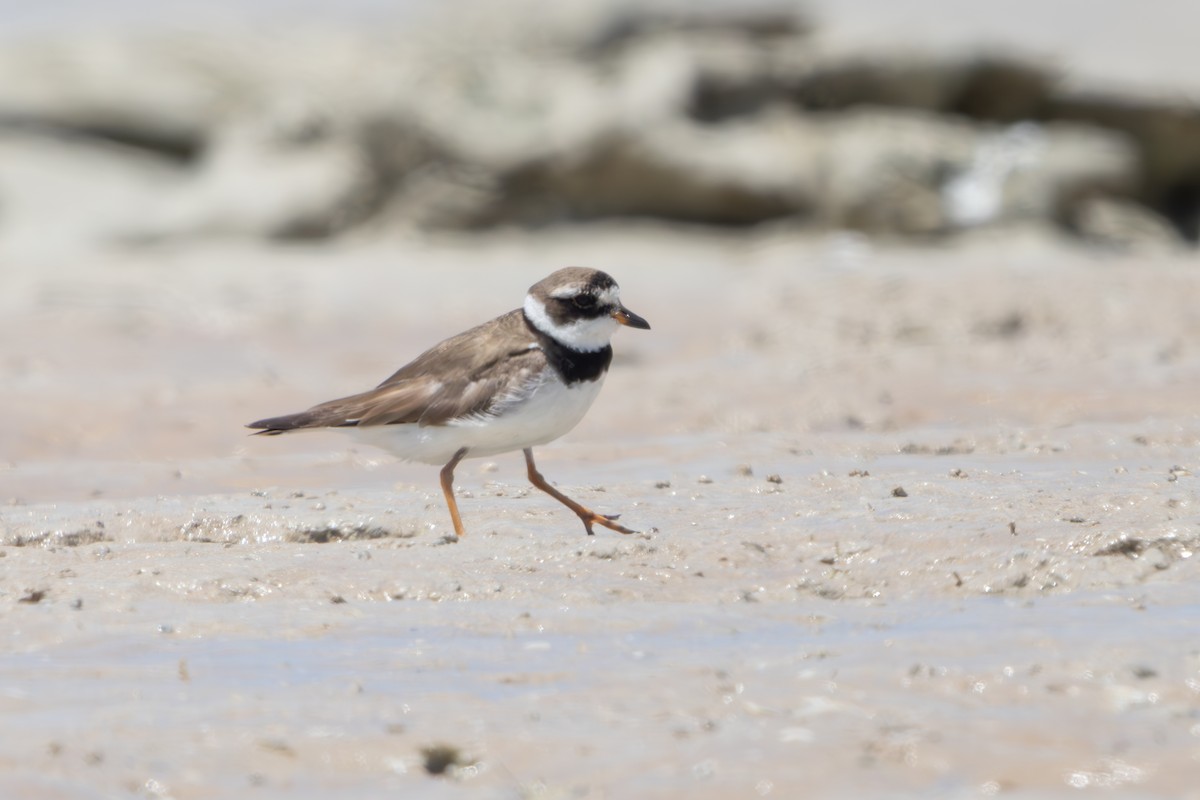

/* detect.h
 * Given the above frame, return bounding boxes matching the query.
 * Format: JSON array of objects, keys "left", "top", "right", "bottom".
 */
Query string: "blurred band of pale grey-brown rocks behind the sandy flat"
[{"left": 0, "top": 0, "right": 1200, "bottom": 246}]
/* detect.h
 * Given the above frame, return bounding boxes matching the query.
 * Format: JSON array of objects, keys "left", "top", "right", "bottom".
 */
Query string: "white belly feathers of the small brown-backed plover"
[{"left": 337, "top": 374, "right": 604, "bottom": 465}]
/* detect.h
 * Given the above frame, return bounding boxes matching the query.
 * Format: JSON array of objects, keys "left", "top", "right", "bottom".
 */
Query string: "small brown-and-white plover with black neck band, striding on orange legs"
[{"left": 246, "top": 266, "right": 650, "bottom": 539}]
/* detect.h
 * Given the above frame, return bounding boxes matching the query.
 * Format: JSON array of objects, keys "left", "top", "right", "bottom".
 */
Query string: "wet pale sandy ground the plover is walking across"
[{"left": 0, "top": 227, "right": 1200, "bottom": 798}]
